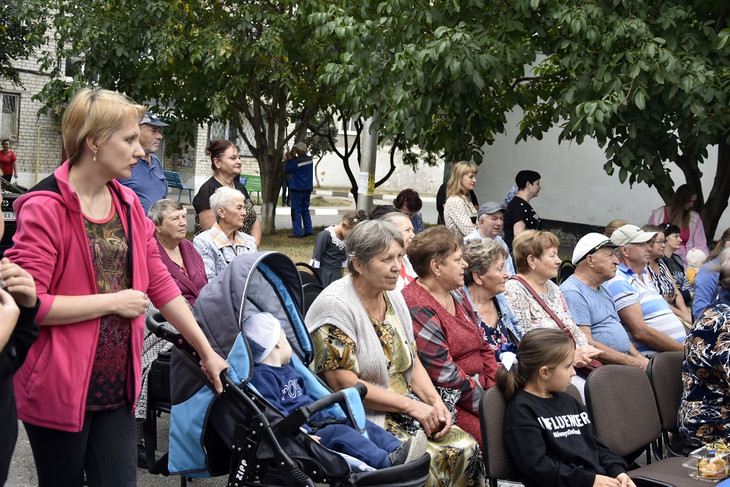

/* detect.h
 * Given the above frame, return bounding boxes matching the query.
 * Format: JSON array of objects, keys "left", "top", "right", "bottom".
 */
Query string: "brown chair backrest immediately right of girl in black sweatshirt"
[{"left": 585, "top": 364, "right": 661, "bottom": 456}]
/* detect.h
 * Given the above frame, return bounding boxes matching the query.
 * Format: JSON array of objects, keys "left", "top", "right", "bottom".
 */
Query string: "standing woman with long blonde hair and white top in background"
[{"left": 444, "top": 161, "right": 479, "bottom": 240}]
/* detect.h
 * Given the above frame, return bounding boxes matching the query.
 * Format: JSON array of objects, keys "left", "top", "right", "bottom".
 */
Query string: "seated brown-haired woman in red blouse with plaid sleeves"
[{"left": 402, "top": 226, "right": 497, "bottom": 446}]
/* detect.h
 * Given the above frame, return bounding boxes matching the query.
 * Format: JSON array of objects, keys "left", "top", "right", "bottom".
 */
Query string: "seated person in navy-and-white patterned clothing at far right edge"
[{"left": 679, "top": 249, "right": 730, "bottom": 448}]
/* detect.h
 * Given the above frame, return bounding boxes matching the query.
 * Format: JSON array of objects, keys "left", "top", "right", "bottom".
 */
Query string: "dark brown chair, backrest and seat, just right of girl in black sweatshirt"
[{"left": 585, "top": 364, "right": 712, "bottom": 487}]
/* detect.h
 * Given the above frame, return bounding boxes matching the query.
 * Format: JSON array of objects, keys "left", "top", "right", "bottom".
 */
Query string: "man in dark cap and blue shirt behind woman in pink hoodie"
[{"left": 119, "top": 112, "right": 170, "bottom": 214}]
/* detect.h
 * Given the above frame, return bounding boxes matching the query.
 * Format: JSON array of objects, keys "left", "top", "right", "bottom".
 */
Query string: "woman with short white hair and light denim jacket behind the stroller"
[{"left": 193, "top": 186, "right": 257, "bottom": 280}]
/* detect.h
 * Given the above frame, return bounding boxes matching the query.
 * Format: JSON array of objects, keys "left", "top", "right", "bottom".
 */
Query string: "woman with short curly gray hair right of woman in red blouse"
[{"left": 462, "top": 238, "right": 522, "bottom": 351}]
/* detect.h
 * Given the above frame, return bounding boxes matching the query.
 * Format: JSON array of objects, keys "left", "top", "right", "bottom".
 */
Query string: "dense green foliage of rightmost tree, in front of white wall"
[{"left": 515, "top": 0, "right": 730, "bottom": 236}]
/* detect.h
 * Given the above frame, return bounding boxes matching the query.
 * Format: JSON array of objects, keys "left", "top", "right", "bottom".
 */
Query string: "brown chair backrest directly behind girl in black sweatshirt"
[{"left": 479, "top": 387, "right": 520, "bottom": 486}]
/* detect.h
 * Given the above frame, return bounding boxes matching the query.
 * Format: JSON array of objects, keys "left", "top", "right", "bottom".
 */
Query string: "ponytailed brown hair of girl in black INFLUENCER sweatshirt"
[{"left": 495, "top": 328, "right": 575, "bottom": 401}]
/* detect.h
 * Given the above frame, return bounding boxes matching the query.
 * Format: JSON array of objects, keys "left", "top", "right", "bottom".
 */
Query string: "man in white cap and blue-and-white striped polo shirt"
[{"left": 607, "top": 224, "right": 687, "bottom": 355}]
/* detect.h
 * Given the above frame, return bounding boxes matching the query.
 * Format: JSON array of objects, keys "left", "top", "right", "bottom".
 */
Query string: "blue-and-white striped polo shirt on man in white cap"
[{"left": 606, "top": 264, "right": 687, "bottom": 354}]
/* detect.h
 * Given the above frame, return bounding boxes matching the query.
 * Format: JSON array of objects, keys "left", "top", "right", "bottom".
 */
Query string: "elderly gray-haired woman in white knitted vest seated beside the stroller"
[{"left": 305, "top": 220, "right": 485, "bottom": 487}]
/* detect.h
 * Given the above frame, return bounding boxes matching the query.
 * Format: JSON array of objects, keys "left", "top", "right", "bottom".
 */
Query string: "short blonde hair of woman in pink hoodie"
[{"left": 61, "top": 88, "right": 145, "bottom": 168}]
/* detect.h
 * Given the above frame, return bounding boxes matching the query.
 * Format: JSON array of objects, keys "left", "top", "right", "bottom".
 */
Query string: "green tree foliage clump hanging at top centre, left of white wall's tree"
[{"left": 309, "top": 0, "right": 535, "bottom": 161}]
